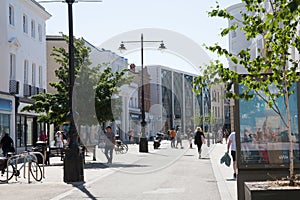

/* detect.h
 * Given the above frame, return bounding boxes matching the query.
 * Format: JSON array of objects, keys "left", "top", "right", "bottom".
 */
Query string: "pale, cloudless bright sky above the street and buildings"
[{"left": 37, "top": 0, "right": 241, "bottom": 73}]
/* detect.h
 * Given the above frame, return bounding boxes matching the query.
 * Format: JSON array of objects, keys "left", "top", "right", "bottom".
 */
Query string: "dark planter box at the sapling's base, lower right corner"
[{"left": 244, "top": 181, "right": 300, "bottom": 200}]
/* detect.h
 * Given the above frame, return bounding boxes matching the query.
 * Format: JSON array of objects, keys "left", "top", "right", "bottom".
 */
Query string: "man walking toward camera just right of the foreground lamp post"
[{"left": 104, "top": 126, "right": 116, "bottom": 164}]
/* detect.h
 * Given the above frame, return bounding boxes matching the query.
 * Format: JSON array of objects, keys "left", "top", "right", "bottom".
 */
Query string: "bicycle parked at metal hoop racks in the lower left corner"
[{"left": 0, "top": 152, "right": 44, "bottom": 182}]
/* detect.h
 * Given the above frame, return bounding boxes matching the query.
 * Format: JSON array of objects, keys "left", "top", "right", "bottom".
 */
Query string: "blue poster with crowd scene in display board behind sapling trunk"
[{"left": 239, "top": 84, "right": 300, "bottom": 166}]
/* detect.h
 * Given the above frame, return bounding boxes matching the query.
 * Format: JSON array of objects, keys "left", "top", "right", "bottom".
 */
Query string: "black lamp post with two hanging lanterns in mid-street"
[{"left": 119, "top": 34, "right": 166, "bottom": 153}]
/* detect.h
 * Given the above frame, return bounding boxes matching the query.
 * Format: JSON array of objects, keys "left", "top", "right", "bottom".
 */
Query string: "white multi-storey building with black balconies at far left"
[{"left": 0, "top": 0, "right": 51, "bottom": 151}]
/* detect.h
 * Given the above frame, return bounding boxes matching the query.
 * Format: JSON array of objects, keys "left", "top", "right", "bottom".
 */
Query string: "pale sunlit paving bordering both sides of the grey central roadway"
[{"left": 0, "top": 141, "right": 237, "bottom": 200}]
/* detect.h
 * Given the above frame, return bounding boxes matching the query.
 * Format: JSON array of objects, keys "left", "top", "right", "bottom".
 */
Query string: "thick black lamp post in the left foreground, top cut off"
[{"left": 64, "top": 0, "right": 84, "bottom": 182}]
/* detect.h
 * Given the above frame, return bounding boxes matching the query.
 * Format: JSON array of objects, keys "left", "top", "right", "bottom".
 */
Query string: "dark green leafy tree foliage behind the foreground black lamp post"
[{"left": 23, "top": 35, "right": 130, "bottom": 131}]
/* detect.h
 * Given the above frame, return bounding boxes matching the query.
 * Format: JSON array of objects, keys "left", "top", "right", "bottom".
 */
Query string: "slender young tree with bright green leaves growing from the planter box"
[{"left": 195, "top": 0, "right": 300, "bottom": 185}]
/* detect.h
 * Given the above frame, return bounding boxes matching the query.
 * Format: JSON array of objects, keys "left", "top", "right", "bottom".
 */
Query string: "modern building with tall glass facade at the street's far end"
[{"left": 147, "top": 65, "right": 210, "bottom": 133}]
